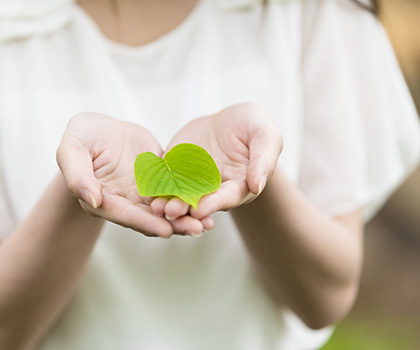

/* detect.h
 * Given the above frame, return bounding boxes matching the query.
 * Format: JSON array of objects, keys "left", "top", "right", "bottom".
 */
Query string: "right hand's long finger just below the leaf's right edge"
[{"left": 190, "top": 180, "right": 249, "bottom": 219}]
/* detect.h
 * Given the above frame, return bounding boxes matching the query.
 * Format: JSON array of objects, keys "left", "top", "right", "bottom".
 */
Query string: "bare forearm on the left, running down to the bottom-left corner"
[{"left": 0, "top": 174, "right": 103, "bottom": 349}]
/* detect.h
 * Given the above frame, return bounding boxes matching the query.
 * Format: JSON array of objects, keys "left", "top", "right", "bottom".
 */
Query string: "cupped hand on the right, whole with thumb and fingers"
[{"left": 151, "top": 103, "right": 283, "bottom": 218}]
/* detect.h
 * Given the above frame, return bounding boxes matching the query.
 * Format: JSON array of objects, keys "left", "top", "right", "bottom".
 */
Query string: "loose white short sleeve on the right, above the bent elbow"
[{"left": 300, "top": 0, "right": 420, "bottom": 220}]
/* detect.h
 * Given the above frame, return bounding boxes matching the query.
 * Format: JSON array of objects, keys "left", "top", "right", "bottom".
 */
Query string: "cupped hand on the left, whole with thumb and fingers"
[{"left": 57, "top": 113, "right": 213, "bottom": 237}]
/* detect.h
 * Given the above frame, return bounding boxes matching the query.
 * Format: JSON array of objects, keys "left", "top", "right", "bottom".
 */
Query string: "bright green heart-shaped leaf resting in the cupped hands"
[{"left": 134, "top": 143, "right": 221, "bottom": 209}]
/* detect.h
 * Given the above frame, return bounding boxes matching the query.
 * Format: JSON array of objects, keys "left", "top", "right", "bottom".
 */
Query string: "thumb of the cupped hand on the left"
[{"left": 56, "top": 136, "right": 102, "bottom": 209}]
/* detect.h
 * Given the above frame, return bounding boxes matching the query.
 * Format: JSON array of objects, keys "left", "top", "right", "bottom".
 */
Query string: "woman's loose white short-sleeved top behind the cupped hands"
[{"left": 0, "top": 0, "right": 420, "bottom": 350}]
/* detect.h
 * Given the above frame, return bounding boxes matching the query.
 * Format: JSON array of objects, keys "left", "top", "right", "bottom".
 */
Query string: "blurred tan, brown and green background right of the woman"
[{"left": 322, "top": 0, "right": 420, "bottom": 350}]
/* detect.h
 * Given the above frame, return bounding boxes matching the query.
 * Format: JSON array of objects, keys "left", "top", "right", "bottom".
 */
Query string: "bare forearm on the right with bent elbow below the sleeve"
[{"left": 232, "top": 169, "right": 362, "bottom": 328}]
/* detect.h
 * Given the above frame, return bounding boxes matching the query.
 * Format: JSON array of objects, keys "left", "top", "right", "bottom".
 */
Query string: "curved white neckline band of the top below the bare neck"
[{"left": 75, "top": 0, "right": 205, "bottom": 58}]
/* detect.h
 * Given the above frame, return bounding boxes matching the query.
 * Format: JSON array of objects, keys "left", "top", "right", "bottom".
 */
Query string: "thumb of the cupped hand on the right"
[{"left": 246, "top": 127, "right": 283, "bottom": 195}]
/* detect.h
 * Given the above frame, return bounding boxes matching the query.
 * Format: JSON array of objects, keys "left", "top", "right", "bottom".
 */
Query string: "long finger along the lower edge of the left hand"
[{"left": 83, "top": 195, "right": 173, "bottom": 238}]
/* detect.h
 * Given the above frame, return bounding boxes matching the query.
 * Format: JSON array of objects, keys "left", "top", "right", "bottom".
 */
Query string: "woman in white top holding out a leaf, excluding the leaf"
[{"left": 0, "top": 0, "right": 420, "bottom": 350}]
